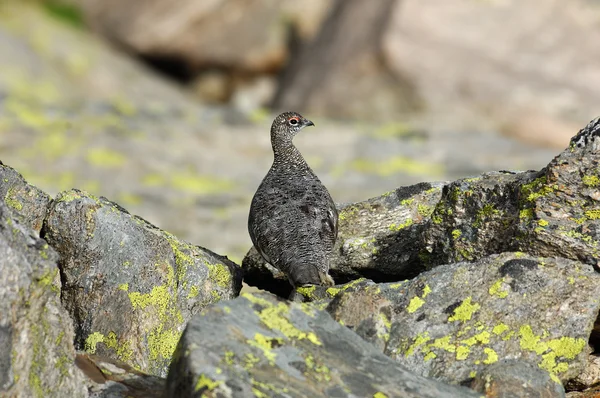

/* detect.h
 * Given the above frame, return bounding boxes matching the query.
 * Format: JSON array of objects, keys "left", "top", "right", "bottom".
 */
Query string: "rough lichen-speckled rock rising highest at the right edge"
[{"left": 516, "top": 118, "right": 600, "bottom": 265}]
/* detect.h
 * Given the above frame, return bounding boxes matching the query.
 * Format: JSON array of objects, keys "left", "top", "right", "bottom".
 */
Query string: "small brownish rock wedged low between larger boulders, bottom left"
[{"left": 75, "top": 354, "right": 165, "bottom": 398}]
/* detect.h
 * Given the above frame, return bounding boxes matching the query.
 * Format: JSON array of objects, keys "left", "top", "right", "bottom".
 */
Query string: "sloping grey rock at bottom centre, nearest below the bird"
[{"left": 166, "top": 293, "right": 478, "bottom": 398}]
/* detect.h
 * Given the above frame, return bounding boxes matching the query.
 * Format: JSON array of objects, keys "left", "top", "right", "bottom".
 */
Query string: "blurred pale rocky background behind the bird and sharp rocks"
[{"left": 0, "top": 0, "right": 600, "bottom": 262}]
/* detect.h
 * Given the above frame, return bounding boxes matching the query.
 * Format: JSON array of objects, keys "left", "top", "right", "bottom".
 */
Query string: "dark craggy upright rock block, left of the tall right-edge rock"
[{"left": 424, "top": 171, "right": 541, "bottom": 267}]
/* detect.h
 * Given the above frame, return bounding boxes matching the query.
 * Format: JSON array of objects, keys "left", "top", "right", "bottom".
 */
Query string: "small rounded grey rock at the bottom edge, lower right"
[{"left": 471, "top": 360, "right": 565, "bottom": 398}]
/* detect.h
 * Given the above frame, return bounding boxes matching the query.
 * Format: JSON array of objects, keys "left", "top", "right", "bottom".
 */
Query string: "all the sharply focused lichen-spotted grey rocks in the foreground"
[{"left": 0, "top": 119, "right": 600, "bottom": 398}]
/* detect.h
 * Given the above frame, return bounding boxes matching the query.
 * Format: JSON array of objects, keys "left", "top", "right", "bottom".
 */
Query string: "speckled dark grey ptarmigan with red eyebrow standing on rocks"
[{"left": 248, "top": 112, "right": 338, "bottom": 295}]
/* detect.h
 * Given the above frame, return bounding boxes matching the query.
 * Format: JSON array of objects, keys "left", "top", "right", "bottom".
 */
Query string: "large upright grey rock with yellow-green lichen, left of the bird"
[{"left": 43, "top": 190, "right": 241, "bottom": 375}]
